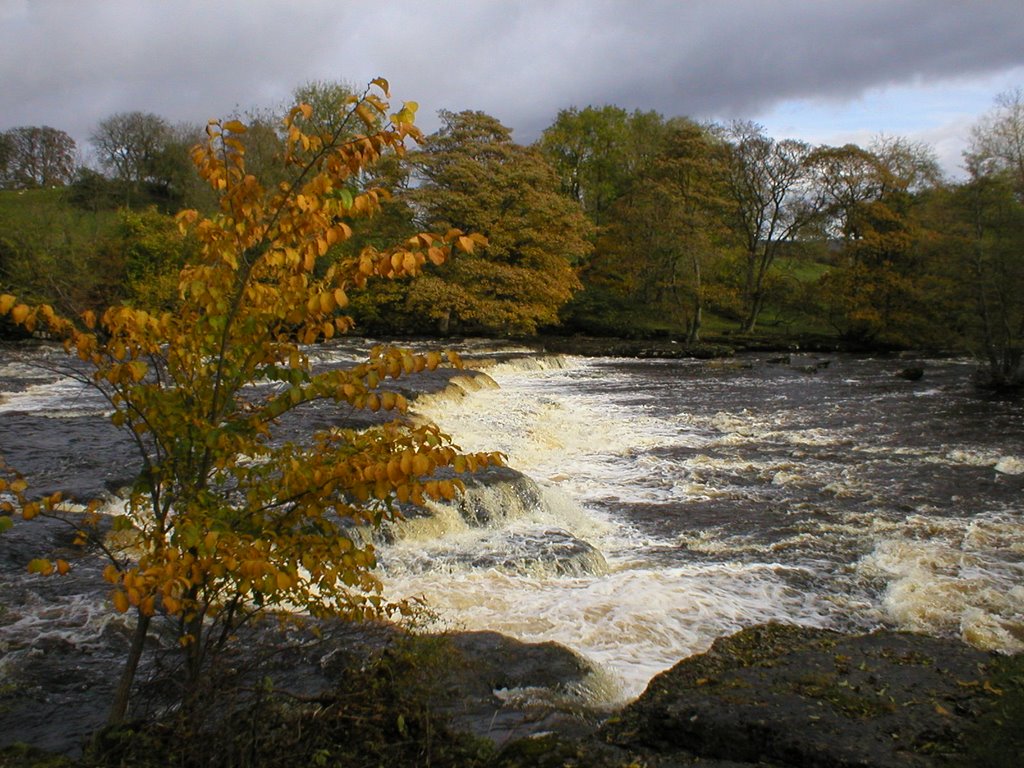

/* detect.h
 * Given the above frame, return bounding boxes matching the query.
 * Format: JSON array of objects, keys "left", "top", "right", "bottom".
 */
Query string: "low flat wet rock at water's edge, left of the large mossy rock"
[{"left": 232, "top": 622, "right": 607, "bottom": 744}]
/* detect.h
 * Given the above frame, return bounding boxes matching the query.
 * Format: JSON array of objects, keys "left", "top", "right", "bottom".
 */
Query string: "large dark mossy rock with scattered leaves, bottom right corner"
[{"left": 602, "top": 625, "right": 1022, "bottom": 768}]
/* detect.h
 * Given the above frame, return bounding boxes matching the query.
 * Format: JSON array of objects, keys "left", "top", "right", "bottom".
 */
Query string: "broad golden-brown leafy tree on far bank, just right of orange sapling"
[{"left": 372, "top": 112, "right": 590, "bottom": 334}]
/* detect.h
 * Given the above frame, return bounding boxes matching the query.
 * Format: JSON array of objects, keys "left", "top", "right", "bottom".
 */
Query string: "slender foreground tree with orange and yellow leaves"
[{"left": 0, "top": 79, "right": 500, "bottom": 722}]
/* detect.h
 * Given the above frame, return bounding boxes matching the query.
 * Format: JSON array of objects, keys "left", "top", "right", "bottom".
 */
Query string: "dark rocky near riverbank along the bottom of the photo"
[{"left": 0, "top": 624, "right": 1024, "bottom": 768}]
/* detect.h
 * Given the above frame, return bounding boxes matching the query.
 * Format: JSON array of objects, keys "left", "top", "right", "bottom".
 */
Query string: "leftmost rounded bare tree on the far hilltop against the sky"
[{"left": 0, "top": 125, "right": 78, "bottom": 189}]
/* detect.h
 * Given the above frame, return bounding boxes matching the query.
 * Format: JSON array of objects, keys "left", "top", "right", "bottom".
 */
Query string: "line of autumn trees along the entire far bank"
[{"left": 0, "top": 82, "right": 1024, "bottom": 383}]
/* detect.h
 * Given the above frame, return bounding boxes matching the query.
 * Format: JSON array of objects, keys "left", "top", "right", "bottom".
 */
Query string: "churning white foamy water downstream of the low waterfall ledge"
[{"left": 374, "top": 358, "right": 1024, "bottom": 697}]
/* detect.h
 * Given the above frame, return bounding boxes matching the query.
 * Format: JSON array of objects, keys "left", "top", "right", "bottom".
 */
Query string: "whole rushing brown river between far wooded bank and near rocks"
[{"left": 0, "top": 343, "right": 1024, "bottom": 703}]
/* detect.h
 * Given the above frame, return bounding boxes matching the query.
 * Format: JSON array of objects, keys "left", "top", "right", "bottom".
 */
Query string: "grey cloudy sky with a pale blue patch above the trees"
[{"left": 0, "top": 0, "right": 1024, "bottom": 172}]
